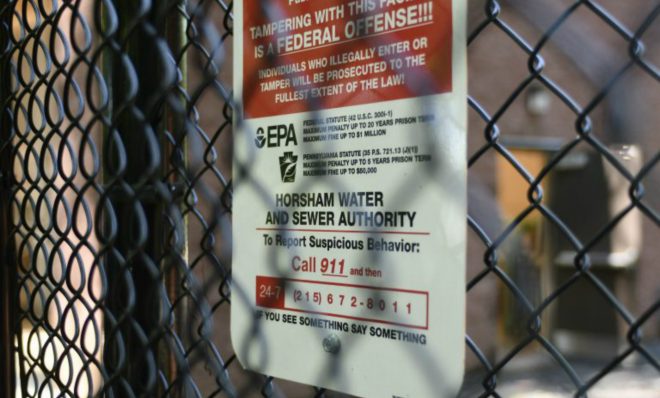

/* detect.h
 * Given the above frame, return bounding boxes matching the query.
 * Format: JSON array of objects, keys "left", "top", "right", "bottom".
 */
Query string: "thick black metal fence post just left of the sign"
[{"left": 104, "top": 0, "right": 187, "bottom": 397}]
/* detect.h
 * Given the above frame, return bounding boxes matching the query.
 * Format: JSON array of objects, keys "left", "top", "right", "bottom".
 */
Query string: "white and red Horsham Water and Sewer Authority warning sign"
[{"left": 231, "top": 0, "right": 467, "bottom": 397}]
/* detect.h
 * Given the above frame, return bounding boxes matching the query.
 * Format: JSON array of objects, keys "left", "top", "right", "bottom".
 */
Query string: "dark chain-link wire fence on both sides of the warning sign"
[{"left": 0, "top": 0, "right": 660, "bottom": 397}]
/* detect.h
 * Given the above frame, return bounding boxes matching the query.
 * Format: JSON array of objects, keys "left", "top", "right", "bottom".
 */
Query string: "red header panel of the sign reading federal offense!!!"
[{"left": 243, "top": 0, "right": 452, "bottom": 119}]
